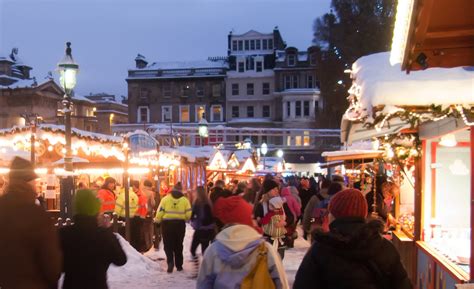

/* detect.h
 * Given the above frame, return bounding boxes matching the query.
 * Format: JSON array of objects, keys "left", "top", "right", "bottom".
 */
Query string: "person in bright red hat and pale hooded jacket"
[{"left": 196, "top": 196, "right": 289, "bottom": 289}]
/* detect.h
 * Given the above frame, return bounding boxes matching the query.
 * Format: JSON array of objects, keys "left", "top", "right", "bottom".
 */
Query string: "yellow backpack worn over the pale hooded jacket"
[{"left": 240, "top": 242, "right": 276, "bottom": 289}]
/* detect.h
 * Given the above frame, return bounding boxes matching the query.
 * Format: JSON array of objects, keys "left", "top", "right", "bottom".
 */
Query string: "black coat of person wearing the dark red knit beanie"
[{"left": 293, "top": 218, "right": 412, "bottom": 289}]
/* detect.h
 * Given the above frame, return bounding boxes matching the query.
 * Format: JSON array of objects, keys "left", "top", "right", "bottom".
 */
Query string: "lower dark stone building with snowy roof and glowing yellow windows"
[{"left": 127, "top": 55, "right": 227, "bottom": 124}]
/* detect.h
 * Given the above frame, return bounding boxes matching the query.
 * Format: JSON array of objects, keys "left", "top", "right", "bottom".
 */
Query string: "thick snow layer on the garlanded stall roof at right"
[{"left": 351, "top": 52, "right": 474, "bottom": 115}]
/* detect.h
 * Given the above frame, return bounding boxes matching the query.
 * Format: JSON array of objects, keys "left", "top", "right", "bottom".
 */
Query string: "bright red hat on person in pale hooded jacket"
[{"left": 214, "top": 196, "right": 254, "bottom": 227}]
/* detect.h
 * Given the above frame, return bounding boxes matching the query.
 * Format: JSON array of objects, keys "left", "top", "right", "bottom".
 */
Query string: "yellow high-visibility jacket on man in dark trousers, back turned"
[{"left": 155, "top": 194, "right": 191, "bottom": 223}]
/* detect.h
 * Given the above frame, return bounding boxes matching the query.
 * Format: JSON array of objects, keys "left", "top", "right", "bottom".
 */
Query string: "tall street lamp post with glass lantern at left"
[{"left": 58, "top": 42, "right": 79, "bottom": 218}]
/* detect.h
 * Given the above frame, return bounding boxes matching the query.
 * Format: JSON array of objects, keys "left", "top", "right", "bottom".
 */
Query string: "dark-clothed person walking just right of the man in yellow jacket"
[{"left": 191, "top": 186, "right": 216, "bottom": 278}]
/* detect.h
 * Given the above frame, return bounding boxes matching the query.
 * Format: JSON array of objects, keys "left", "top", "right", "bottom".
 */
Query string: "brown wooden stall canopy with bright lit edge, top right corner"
[{"left": 391, "top": 0, "right": 474, "bottom": 72}]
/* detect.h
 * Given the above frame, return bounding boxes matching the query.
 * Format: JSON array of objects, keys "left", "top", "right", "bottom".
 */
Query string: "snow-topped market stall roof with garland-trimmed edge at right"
[{"left": 341, "top": 52, "right": 474, "bottom": 141}]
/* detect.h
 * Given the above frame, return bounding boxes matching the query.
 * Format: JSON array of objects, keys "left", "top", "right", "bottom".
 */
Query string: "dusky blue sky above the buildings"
[{"left": 0, "top": 0, "right": 330, "bottom": 95}]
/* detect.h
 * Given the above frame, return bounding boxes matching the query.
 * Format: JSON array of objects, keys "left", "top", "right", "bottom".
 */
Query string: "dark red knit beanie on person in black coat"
[{"left": 328, "top": 189, "right": 368, "bottom": 219}]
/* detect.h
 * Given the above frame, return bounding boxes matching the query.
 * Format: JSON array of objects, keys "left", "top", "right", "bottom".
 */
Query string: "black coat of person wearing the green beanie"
[{"left": 60, "top": 215, "right": 127, "bottom": 289}]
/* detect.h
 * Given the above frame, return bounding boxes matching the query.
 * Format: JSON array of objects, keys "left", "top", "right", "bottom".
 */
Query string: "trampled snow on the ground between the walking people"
[{"left": 108, "top": 225, "right": 309, "bottom": 289}]
